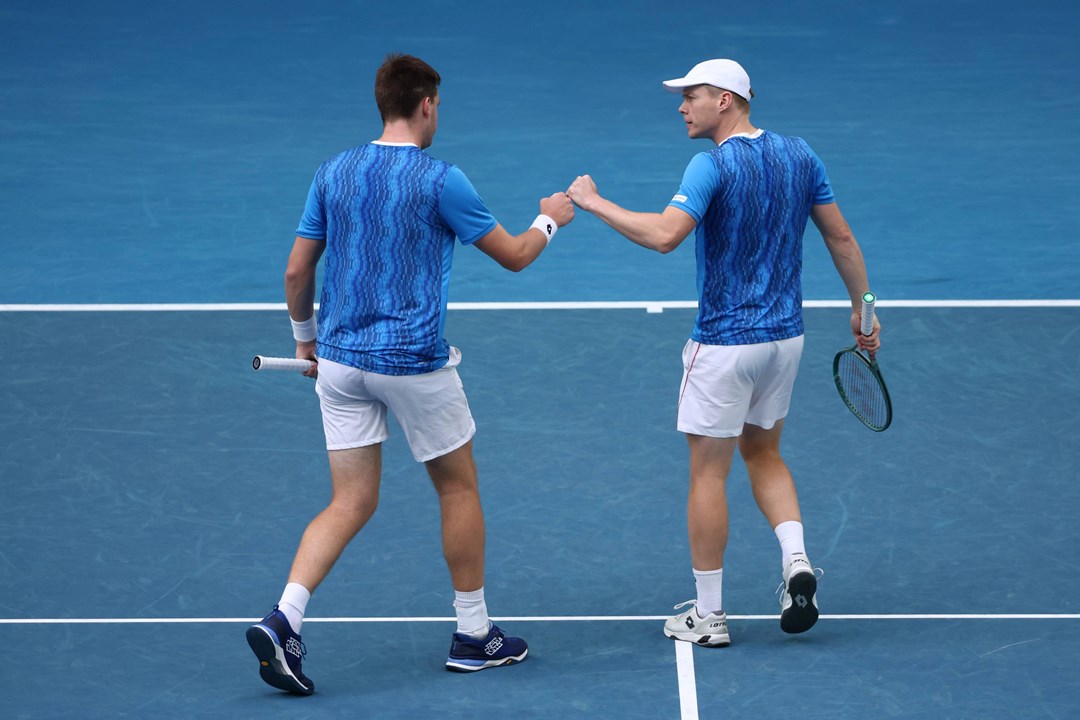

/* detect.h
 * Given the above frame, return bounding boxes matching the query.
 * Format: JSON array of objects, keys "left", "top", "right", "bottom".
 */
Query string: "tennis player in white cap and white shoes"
[{"left": 569, "top": 59, "right": 880, "bottom": 647}]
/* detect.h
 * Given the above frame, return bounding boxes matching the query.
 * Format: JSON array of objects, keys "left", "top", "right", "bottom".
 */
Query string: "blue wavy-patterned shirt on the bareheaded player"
[{"left": 296, "top": 142, "right": 497, "bottom": 375}]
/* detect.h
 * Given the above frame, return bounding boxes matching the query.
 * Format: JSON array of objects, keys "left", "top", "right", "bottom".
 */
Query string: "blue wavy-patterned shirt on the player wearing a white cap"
[{"left": 669, "top": 131, "right": 835, "bottom": 345}]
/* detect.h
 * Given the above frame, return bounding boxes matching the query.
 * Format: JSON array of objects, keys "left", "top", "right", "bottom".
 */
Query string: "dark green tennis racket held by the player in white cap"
[{"left": 833, "top": 293, "right": 892, "bottom": 433}]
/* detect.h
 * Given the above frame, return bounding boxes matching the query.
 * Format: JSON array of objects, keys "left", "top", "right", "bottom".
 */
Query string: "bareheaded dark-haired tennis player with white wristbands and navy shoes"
[{"left": 247, "top": 50, "right": 573, "bottom": 694}]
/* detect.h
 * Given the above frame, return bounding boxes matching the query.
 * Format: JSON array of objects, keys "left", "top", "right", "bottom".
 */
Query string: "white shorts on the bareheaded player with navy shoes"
[{"left": 315, "top": 348, "right": 476, "bottom": 462}]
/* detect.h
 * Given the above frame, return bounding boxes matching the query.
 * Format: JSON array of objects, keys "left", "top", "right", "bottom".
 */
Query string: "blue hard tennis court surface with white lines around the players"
[{"left": 0, "top": 0, "right": 1080, "bottom": 720}]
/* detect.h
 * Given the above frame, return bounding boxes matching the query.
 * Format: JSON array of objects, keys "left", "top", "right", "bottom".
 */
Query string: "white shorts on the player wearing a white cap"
[{"left": 678, "top": 336, "right": 802, "bottom": 437}]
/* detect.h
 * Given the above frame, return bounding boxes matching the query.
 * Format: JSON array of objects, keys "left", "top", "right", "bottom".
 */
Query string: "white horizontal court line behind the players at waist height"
[{"left": 0, "top": 299, "right": 1080, "bottom": 313}]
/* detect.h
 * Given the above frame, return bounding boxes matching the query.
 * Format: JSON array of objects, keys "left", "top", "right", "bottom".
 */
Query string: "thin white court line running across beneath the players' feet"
[{"left": 0, "top": 613, "right": 1080, "bottom": 625}]
